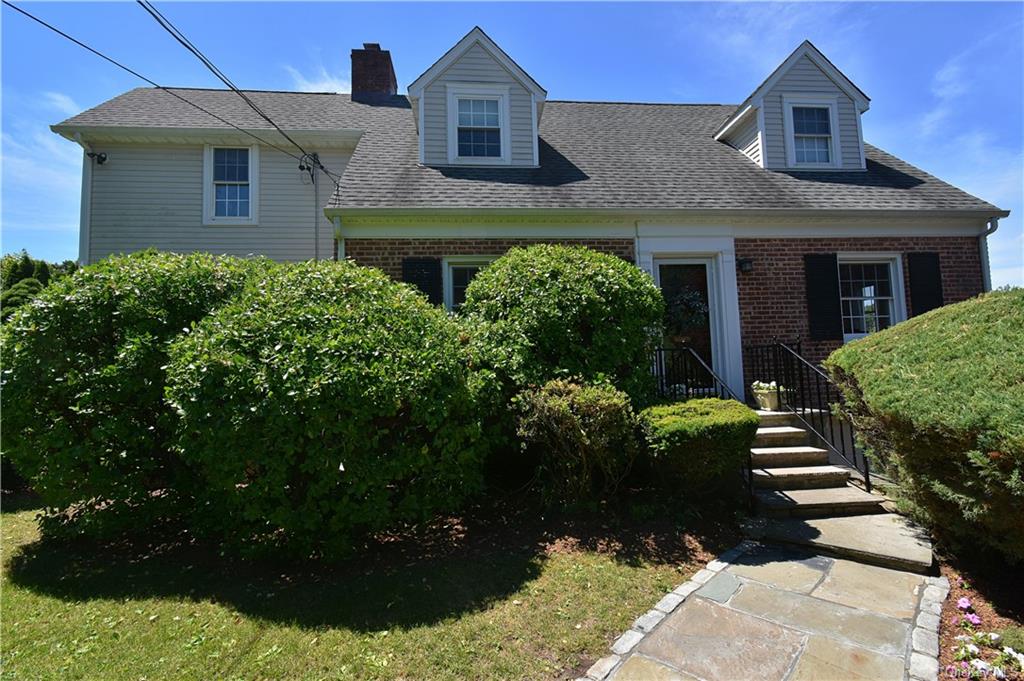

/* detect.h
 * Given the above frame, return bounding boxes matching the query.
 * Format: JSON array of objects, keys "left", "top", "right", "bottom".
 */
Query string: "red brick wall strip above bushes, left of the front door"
[{"left": 345, "top": 239, "right": 635, "bottom": 279}]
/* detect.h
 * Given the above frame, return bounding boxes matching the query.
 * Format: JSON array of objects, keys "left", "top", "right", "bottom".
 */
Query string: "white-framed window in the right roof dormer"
[{"left": 782, "top": 95, "right": 843, "bottom": 168}]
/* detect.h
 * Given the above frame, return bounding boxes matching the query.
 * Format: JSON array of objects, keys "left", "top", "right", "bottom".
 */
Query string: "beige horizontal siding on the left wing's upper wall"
[{"left": 88, "top": 144, "right": 350, "bottom": 262}]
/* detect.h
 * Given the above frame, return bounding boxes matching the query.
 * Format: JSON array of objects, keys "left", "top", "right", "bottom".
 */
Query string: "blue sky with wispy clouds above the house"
[{"left": 0, "top": 0, "right": 1024, "bottom": 286}]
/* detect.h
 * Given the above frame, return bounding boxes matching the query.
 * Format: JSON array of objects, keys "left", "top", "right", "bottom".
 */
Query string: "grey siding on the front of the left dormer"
[{"left": 422, "top": 43, "right": 535, "bottom": 166}]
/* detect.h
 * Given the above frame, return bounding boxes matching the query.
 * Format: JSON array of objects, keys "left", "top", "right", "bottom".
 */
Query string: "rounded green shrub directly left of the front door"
[{"left": 462, "top": 245, "right": 665, "bottom": 398}]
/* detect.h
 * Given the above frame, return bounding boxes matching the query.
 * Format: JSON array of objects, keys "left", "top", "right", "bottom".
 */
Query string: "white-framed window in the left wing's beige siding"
[{"left": 203, "top": 144, "right": 259, "bottom": 225}]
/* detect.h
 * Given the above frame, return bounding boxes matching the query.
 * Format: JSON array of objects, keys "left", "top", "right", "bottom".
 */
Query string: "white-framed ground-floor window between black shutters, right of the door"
[{"left": 838, "top": 253, "right": 906, "bottom": 342}]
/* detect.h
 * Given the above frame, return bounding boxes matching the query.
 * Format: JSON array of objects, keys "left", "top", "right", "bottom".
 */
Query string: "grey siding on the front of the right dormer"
[{"left": 763, "top": 56, "right": 862, "bottom": 170}]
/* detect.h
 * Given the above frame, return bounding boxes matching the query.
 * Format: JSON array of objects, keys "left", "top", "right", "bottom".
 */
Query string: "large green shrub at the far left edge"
[{"left": 0, "top": 252, "right": 264, "bottom": 526}]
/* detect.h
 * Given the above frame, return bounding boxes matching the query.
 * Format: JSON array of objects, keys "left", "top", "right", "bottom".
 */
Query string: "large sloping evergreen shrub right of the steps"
[{"left": 825, "top": 289, "right": 1024, "bottom": 560}]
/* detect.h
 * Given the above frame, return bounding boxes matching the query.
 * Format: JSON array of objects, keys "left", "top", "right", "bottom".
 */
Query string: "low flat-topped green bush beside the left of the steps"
[{"left": 640, "top": 397, "right": 760, "bottom": 494}]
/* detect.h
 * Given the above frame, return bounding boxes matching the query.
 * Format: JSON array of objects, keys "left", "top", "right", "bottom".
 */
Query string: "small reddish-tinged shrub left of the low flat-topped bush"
[{"left": 514, "top": 379, "right": 637, "bottom": 502}]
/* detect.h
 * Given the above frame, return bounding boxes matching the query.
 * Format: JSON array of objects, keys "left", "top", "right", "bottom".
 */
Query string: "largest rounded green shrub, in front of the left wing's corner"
[{"left": 168, "top": 262, "right": 481, "bottom": 555}]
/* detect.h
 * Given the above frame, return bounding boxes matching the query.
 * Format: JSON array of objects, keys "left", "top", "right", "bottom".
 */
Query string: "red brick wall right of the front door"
[{"left": 735, "top": 237, "right": 983, "bottom": 372}]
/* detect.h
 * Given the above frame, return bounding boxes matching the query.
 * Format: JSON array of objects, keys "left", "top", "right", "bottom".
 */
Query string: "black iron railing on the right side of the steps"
[{"left": 744, "top": 340, "right": 871, "bottom": 492}]
